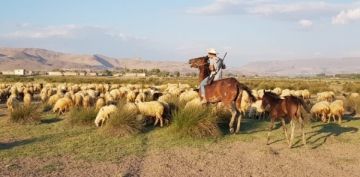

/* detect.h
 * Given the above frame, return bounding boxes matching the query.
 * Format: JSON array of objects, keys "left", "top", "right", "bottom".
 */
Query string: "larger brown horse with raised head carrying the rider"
[{"left": 189, "top": 56, "right": 256, "bottom": 133}]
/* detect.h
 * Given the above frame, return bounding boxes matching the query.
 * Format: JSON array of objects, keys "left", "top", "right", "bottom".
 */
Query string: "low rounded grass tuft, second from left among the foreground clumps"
[{"left": 68, "top": 107, "right": 97, "bottom": 125}]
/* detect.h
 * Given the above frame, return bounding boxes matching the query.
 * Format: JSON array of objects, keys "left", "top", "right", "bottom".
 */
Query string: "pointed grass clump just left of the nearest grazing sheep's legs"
[{"left": 102, "top": 102, "right": 145, "bottom": 136}]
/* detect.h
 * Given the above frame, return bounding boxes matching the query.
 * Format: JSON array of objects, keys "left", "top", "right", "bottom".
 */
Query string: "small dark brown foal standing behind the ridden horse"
[{"left": 262, "top": 91, "right": 309, "bottom": 148}]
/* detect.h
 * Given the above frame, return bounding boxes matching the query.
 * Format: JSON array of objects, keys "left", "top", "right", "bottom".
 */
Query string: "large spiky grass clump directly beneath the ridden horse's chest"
[{"left": 172, "top": 107, "right": 222, "bottom": 138}]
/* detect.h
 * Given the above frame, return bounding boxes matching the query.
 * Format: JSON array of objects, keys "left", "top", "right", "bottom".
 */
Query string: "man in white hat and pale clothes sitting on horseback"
[{"left": 200, "top": 48, "right": 225, "bottom": 103}]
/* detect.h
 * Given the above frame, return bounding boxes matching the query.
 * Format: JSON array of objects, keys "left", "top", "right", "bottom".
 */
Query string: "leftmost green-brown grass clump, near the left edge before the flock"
[{"left": 10, "top": 105, "right": 41, "bottom": 124}]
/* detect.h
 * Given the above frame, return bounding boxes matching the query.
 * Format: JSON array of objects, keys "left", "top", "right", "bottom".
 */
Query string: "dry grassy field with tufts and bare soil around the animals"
[{"left": 0, "top": 77, "right": 360, "bottom": 176}]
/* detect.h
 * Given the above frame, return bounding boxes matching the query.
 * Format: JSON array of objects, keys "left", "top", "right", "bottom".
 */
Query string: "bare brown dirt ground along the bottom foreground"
[{"left": 0, "top": 103, "right": 360, "bottom": 177}]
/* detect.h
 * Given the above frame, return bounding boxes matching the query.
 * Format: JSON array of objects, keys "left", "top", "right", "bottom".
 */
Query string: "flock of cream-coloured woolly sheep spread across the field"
[{"left": 0, "top": 83, "right": 359, "bottom": 127}]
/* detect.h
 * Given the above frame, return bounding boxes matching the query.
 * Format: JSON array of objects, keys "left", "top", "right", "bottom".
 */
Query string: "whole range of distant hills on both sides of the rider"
[{"left": 0, "top": 48, "right": 360, "bottom": 76}]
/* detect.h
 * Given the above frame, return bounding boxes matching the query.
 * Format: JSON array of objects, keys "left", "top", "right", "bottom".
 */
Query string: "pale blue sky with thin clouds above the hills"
[{"left": 0, "top": 0, "right": 360, "bottom": 67}]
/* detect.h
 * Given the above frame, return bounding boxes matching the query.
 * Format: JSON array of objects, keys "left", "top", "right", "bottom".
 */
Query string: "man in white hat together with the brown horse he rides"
[{"left": 189, "top": 50, "right": 256, "bottom": 133}]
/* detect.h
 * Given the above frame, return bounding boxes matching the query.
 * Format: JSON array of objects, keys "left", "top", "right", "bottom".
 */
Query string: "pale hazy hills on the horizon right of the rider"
[{"left": 238, "top": 58, "right": 360, "bottom": 76}]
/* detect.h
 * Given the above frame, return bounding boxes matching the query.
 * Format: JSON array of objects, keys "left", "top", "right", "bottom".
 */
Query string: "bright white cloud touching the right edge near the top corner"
[{"left": 332, "top": 8, "right": 360, "bottom": 25}]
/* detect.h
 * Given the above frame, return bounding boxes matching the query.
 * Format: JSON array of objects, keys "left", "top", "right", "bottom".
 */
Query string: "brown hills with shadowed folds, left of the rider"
[{"left": 0, "top": 48, "right": 195, "bottom": 72}]
